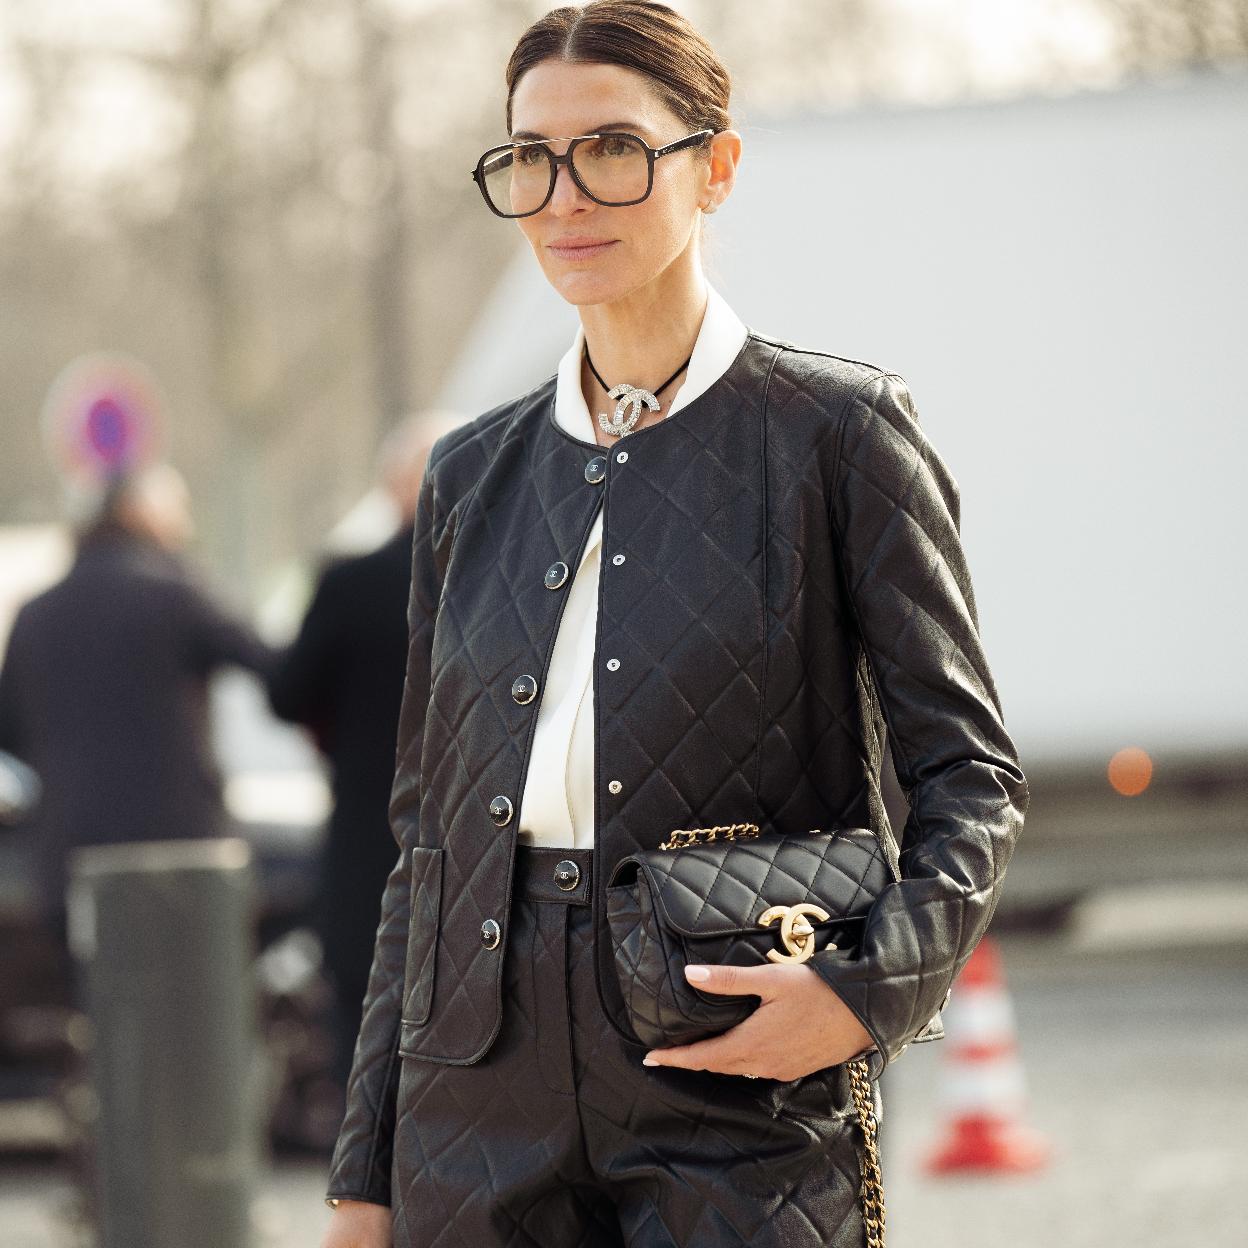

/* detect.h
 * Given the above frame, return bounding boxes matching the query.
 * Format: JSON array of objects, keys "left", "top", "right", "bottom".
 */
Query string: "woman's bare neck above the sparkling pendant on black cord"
[{"left": 580, "top": 259, "right": 706, "bottom": 442}]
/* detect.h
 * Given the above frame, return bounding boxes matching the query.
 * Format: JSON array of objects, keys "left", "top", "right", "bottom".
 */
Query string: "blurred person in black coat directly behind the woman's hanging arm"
[{"left": 270, "top": 413, "right": 459, "bottom": 1090}]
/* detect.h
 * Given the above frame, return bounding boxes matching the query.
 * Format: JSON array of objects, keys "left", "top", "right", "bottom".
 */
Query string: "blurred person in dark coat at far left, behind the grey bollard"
[{"left": 0, "top": 464, "right": 276, "bottom": 952}]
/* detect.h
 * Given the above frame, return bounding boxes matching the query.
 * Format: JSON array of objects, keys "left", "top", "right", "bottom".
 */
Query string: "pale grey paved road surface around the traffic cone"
[{"left": 0, "top": 905, "right": 1248, "bottom": 1248}]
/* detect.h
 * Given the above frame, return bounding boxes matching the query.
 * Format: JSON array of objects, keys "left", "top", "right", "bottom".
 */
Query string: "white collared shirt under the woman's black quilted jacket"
[{"left": 518, "top": 282, "right": 749, "bottom": 849}]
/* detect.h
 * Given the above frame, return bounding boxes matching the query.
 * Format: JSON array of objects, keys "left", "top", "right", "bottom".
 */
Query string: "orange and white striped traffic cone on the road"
[{"left": 924, "top": 937, "right": 1051, "bottom": 1174}]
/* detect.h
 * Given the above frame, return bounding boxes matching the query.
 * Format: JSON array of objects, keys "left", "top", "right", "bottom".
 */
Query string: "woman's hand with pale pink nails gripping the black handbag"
[{"left": 644, "top": 963, "right": 875, "bottom": 1082}]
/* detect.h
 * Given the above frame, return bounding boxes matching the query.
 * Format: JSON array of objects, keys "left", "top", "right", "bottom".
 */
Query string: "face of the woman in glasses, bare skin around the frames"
[{"left": 510, "top": 60, "right": 721, "bottom": 305}]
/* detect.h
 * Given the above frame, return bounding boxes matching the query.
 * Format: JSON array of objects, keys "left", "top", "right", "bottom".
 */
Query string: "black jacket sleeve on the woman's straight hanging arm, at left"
[{"left": 326, "top": 439, "right": 451, "bottom": 1204}]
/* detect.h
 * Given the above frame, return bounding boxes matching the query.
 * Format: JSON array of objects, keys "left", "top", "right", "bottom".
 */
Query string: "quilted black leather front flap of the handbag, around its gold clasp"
[{"left": 612, "top": 827, "right": 892, "bottom": 936}]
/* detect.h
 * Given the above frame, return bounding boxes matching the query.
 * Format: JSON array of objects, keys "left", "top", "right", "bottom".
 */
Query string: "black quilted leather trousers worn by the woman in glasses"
[{"left": 392, "top": 846, "right": 882, "bottom": 1248}]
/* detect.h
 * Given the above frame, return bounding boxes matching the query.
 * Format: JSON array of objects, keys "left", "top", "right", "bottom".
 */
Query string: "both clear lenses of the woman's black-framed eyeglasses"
[{"left": 482, "top": 135, "right": 649, "bottom": 216}]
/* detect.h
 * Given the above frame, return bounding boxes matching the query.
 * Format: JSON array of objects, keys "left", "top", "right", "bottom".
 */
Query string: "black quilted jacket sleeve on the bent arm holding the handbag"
[{"left": 811, "top": 373, "right": 1028, "bottom": 1077}]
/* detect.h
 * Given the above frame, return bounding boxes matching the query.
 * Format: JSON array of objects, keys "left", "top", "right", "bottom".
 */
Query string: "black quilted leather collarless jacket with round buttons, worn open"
[{"left": 328, "top": 332, "right": 1028, "bottom": 1204}]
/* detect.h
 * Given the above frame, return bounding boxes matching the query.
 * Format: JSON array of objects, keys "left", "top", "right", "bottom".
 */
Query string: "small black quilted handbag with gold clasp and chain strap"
[{"left": 607, "top": 824, "right": 896, "bottom": 1248}]
